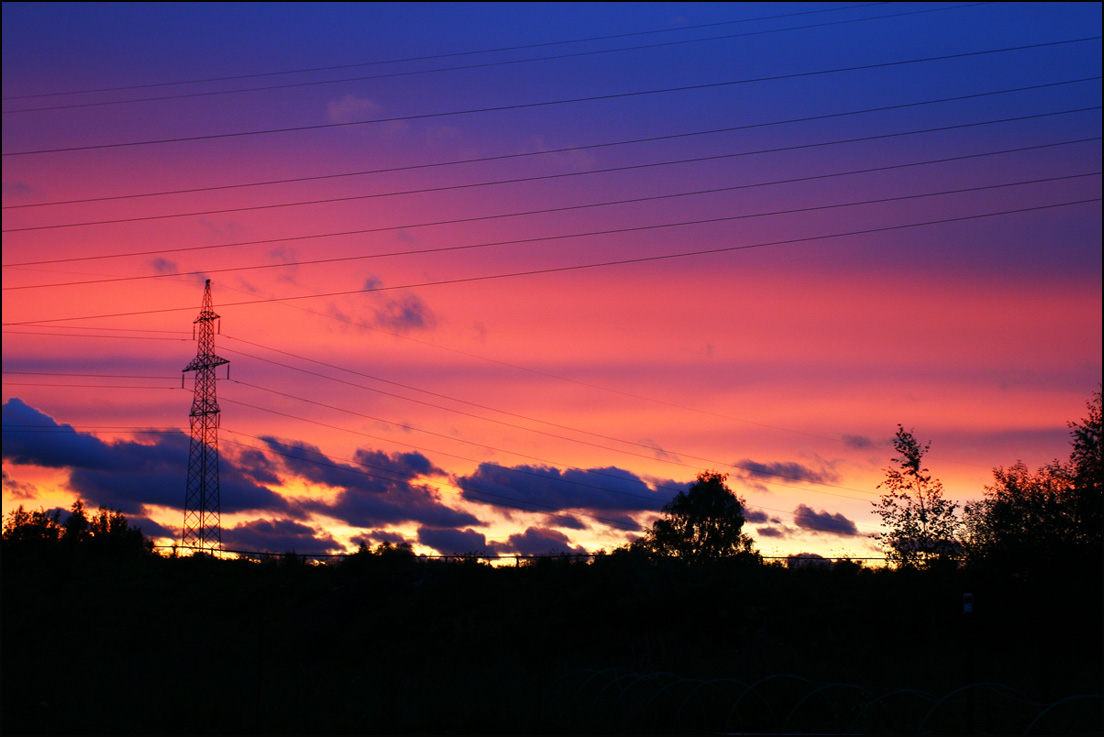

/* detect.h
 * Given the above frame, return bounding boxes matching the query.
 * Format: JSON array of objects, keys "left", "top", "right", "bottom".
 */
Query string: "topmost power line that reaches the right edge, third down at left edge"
[{"left": 2, "top": 35, "right": 1101, "bottom": 157}]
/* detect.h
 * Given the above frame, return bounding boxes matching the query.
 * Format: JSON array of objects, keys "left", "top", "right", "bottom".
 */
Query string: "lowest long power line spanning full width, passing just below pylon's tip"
[{"left": 2, "top": 197, "right": 1101, "bottom": 327}]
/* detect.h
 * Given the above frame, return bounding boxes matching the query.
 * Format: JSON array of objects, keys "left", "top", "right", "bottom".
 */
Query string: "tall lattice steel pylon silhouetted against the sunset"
[{"left": 180, "top": 279, "right": 230, "bottom": 553}]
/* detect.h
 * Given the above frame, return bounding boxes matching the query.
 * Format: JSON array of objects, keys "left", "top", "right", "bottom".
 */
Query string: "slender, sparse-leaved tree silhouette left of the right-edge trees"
[{"left": 873, "top": 425, "right": 962, "bottom": 567}]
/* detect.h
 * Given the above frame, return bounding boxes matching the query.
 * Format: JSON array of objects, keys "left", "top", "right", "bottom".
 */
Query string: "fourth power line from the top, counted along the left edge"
[{"left": 3, "top": 75, "right": 1101, "bottom": 212}]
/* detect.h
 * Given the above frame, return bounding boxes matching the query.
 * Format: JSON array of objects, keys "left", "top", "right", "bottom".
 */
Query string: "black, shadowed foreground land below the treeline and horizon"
[{"left": 2, "top": 555, "right": 1101, "bottom": 734}]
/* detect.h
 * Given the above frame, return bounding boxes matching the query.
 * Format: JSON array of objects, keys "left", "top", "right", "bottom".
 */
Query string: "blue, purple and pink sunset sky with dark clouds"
[{"left": 2, "top": 2, "right": 1102, "bottom": 557}]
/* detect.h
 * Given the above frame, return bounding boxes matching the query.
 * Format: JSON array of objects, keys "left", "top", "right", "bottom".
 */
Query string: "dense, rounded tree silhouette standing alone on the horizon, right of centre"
[{"left": 633, "top": 471, "right": 755, "bottom": 560}]
